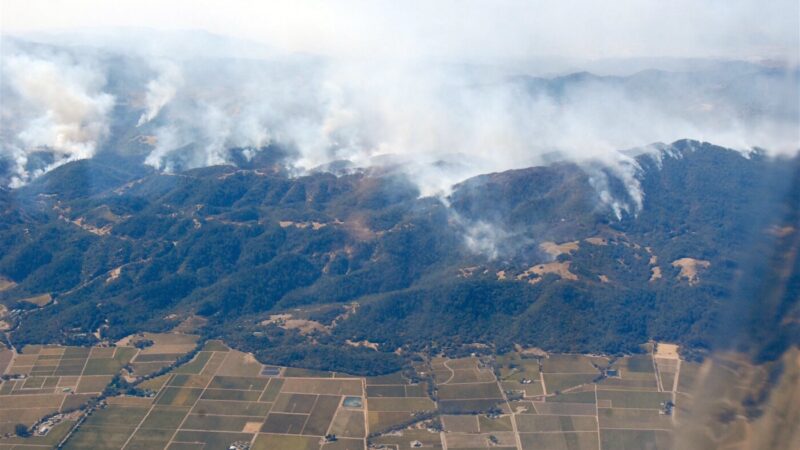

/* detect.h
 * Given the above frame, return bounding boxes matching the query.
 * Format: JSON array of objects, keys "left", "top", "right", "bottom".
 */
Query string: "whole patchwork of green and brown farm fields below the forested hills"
[{"left": 0, "top": 340, "right": 764, "bottom": 450}]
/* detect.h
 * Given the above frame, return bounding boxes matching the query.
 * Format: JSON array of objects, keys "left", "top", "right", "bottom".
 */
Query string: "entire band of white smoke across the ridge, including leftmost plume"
[{"left": 2, "top": 29, "right": 800, "bottom": 204}]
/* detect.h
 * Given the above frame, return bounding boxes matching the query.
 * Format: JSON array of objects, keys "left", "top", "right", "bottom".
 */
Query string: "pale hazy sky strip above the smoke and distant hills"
[{"left": 0, "top": 0, "right": 800, "bottom": 62}]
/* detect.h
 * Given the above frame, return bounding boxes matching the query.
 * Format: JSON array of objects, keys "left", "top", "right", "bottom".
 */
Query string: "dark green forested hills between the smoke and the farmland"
[{"left": 0, "top": 140, "right": 800, "bottom": 373}]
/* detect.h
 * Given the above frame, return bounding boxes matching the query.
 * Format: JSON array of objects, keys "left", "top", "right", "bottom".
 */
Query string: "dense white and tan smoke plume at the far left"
[{"left": 3, "top": 53, "right": 114, "bottom": 185}]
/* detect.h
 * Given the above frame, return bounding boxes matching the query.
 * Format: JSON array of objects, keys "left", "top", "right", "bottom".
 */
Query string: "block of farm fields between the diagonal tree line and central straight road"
[{"left": 54, "top": 341, "right": 367, "bottom": 450}]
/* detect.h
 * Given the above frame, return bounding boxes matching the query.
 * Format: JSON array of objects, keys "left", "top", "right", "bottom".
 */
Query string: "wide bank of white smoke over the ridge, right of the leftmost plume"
[{"left": 138, "top": 56, "right": 800, "bottom": 200}]
